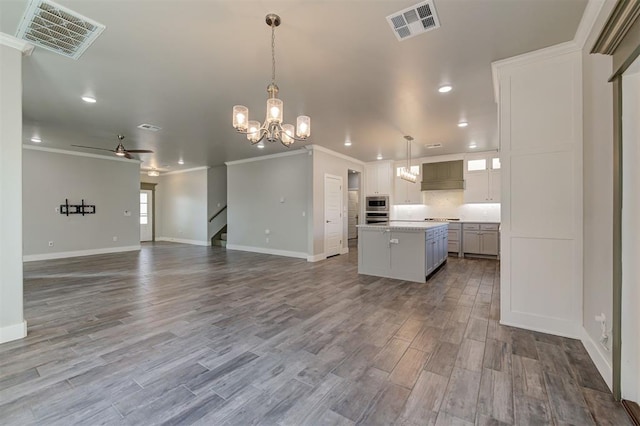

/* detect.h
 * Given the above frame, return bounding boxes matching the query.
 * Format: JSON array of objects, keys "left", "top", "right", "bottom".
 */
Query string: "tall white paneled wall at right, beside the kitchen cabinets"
[{"left": 494, "top": 43, "right": 583, "bottom": 338}]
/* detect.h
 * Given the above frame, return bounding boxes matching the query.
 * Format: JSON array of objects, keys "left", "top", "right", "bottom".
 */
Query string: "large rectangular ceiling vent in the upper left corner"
[{"left": 16, "top": 0, "right": 105, "bottom": 59}]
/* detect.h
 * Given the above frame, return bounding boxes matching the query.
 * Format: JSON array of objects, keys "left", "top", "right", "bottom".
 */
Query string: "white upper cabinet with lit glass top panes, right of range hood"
[{"left": 464, "top": 152, "right": 500, "bottom": 203}]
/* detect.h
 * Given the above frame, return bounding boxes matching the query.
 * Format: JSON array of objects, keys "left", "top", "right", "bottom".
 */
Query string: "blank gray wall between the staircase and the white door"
[{"left": 227, "top": 150, "right": 312, "bottom": 257}]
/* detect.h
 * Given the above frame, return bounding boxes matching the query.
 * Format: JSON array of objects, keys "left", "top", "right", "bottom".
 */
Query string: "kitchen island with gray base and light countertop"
[{"left": 358, "top": 222, "right": 448, "bottom": 283}]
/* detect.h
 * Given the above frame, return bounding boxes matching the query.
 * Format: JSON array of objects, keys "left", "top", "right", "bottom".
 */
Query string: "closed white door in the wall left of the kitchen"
[{"left": 324, "top": 175, "right": 342, "bottom": 257}]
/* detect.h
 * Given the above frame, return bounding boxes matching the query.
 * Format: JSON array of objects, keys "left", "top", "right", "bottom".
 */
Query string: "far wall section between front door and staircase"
[{"left": 156, "top": 167, "right": 210, "bottom": 245}]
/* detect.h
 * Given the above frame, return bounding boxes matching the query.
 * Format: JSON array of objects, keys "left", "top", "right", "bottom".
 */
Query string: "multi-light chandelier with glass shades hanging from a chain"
[{"left": 233, "top": 13, "right": 311, "bottom": 147}]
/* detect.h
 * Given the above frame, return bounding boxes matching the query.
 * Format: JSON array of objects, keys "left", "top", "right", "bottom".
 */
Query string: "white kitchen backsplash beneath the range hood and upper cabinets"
[{"left": 391, "top": 191, "right": 500, "bottom": 222}]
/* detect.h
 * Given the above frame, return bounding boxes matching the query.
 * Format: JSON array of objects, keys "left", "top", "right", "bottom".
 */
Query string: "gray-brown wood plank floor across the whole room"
[{"left": 0, "top": 243, "right": 630, "bottom": 425}]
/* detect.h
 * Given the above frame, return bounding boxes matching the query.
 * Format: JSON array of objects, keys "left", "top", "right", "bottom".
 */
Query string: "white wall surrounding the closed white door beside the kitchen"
[{"left": 310, "top": 145, "right": 364, "bottom": 260}]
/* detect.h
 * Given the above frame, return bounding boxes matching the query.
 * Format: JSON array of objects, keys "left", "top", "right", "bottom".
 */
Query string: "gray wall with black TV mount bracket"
[{"left": 22, "top": 146, "right": 140, "bottom": 257}]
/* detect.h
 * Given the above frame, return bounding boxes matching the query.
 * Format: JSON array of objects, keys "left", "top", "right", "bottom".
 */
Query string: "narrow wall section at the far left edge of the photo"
[{"left": 0, "top": 42, "right": 27, "bottom": 343}]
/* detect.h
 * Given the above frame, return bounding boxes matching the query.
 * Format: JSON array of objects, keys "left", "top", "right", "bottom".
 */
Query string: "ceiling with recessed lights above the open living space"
[{"left": 0, "top": 0, "right": 587, "bottom": 170}]
